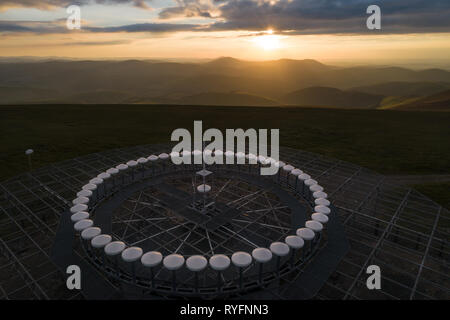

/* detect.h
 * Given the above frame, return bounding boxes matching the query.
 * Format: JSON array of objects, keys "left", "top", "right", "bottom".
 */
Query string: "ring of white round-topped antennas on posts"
[{"left": 70, "top": 150, "right": 331, "bottom": 293}]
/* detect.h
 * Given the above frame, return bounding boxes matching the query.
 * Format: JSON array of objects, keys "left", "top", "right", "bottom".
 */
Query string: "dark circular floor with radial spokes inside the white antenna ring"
[{"left": 96, "top": 166, "right": 306, "bottom": 257}]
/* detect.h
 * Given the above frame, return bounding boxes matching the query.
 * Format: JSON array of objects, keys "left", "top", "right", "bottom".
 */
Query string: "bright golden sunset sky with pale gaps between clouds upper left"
[{"left": 0, "top": 0, "right": 450, "bottom": 65}]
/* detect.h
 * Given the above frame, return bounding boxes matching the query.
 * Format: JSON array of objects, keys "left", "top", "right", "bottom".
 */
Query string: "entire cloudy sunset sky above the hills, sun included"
[{"left": 0, "top": 0, "right": 450, "bottom": 64}]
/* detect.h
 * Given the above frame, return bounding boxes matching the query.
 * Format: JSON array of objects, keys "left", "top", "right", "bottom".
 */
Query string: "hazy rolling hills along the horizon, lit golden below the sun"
[{"left": 0, "top": 57, "right": 450, "bottom": 108}]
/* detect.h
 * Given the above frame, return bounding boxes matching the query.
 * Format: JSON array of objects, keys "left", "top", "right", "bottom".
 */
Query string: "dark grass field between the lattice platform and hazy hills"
[{"left": 0, "top": 105, "right": 450, "bottom": 181}]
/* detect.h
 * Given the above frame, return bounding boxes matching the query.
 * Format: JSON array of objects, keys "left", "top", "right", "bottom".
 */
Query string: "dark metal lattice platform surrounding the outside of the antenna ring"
[{"left": 0, "top": 145, "right": 450, "bottom": 299}]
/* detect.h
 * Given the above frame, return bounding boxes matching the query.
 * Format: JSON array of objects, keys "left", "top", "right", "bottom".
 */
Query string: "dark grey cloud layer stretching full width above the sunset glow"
[{"left": 0, "top": 0, "right": 450, "bottom": 34}]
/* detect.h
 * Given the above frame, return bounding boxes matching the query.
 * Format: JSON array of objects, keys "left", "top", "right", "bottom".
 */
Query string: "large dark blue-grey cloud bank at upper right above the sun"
[{"left": 213, "top": 0, "right": 450, "bottom": 34}]
